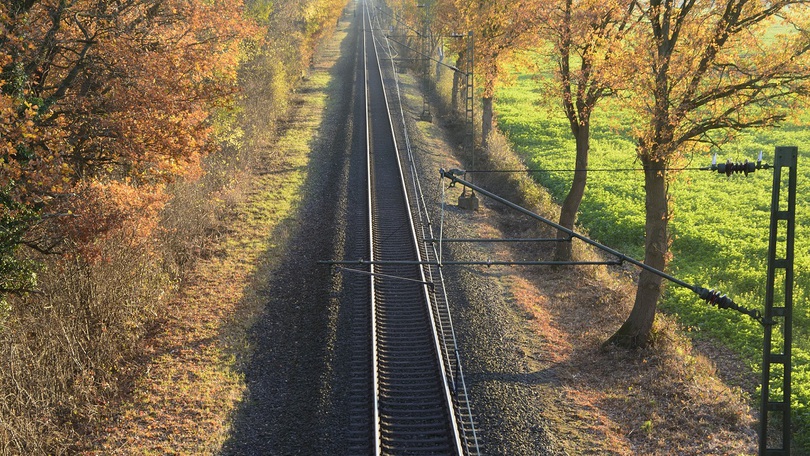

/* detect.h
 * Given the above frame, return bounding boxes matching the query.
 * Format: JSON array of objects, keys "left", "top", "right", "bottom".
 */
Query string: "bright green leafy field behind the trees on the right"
[{"left": 495, "top": 75, "right": 810, "bottom": 448}]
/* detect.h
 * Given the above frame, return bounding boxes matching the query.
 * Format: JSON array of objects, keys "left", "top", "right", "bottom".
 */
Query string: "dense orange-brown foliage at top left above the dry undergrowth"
[{"left": 0, "top": 0, "right": 256, "bottom": 256}]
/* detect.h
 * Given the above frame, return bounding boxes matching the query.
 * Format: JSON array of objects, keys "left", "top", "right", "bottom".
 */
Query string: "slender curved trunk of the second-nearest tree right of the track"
[{"left": 554, "top": 125, "right": 591, "bottom": 261}]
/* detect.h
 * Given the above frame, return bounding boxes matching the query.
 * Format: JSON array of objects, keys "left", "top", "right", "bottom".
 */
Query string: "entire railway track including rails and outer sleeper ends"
[{"left": 338, "top": 2, "right": 478, "bottom": 455}]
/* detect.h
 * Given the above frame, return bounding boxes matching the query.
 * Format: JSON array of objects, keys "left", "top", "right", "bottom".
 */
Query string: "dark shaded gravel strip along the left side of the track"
[{"left": 222, "top": 8, "right": 356, "bottom": 455}]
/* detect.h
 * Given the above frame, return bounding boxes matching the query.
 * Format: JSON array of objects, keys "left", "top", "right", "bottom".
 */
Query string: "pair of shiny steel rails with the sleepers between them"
[{"left": 363, "top": 3, "right": 463, "bottom": 454}]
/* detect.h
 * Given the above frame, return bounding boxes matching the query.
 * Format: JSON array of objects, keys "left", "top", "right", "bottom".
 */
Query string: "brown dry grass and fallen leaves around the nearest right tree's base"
[{"left": 512, "top": 271, "right": 755, "bottom": 455}]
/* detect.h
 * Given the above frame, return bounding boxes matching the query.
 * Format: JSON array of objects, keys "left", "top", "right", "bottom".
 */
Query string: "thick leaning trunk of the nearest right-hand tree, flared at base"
[{"left": 606, "top": 155, "right": 669, "bottom": 348}]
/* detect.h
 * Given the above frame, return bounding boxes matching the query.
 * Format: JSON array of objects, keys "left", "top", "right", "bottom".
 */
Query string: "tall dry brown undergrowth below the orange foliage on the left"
[{"left": 0, "top": 108, "right": 254, "bottom": 454}]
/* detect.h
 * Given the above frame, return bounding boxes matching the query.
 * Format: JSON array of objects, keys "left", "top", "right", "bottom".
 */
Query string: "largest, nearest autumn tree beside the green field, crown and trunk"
[{"left": 609, "top": 0, "right": 810, "bottom": 347}]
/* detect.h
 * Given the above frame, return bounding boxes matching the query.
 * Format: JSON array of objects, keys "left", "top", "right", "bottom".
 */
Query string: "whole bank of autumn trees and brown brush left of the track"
[{"left": 0, "top": 0, "right": 345, "bottom": 454}]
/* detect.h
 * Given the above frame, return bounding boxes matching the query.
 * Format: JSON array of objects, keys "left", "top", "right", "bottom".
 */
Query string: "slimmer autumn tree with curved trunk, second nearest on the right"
[{"left": 539, "top": 0, "right": 637, "bottom": 261}]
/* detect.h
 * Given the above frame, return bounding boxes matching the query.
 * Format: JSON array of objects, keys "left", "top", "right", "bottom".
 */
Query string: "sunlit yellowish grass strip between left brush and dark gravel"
[{"left": 87, "top": 16, "right": 346, "bottom": 454}]
